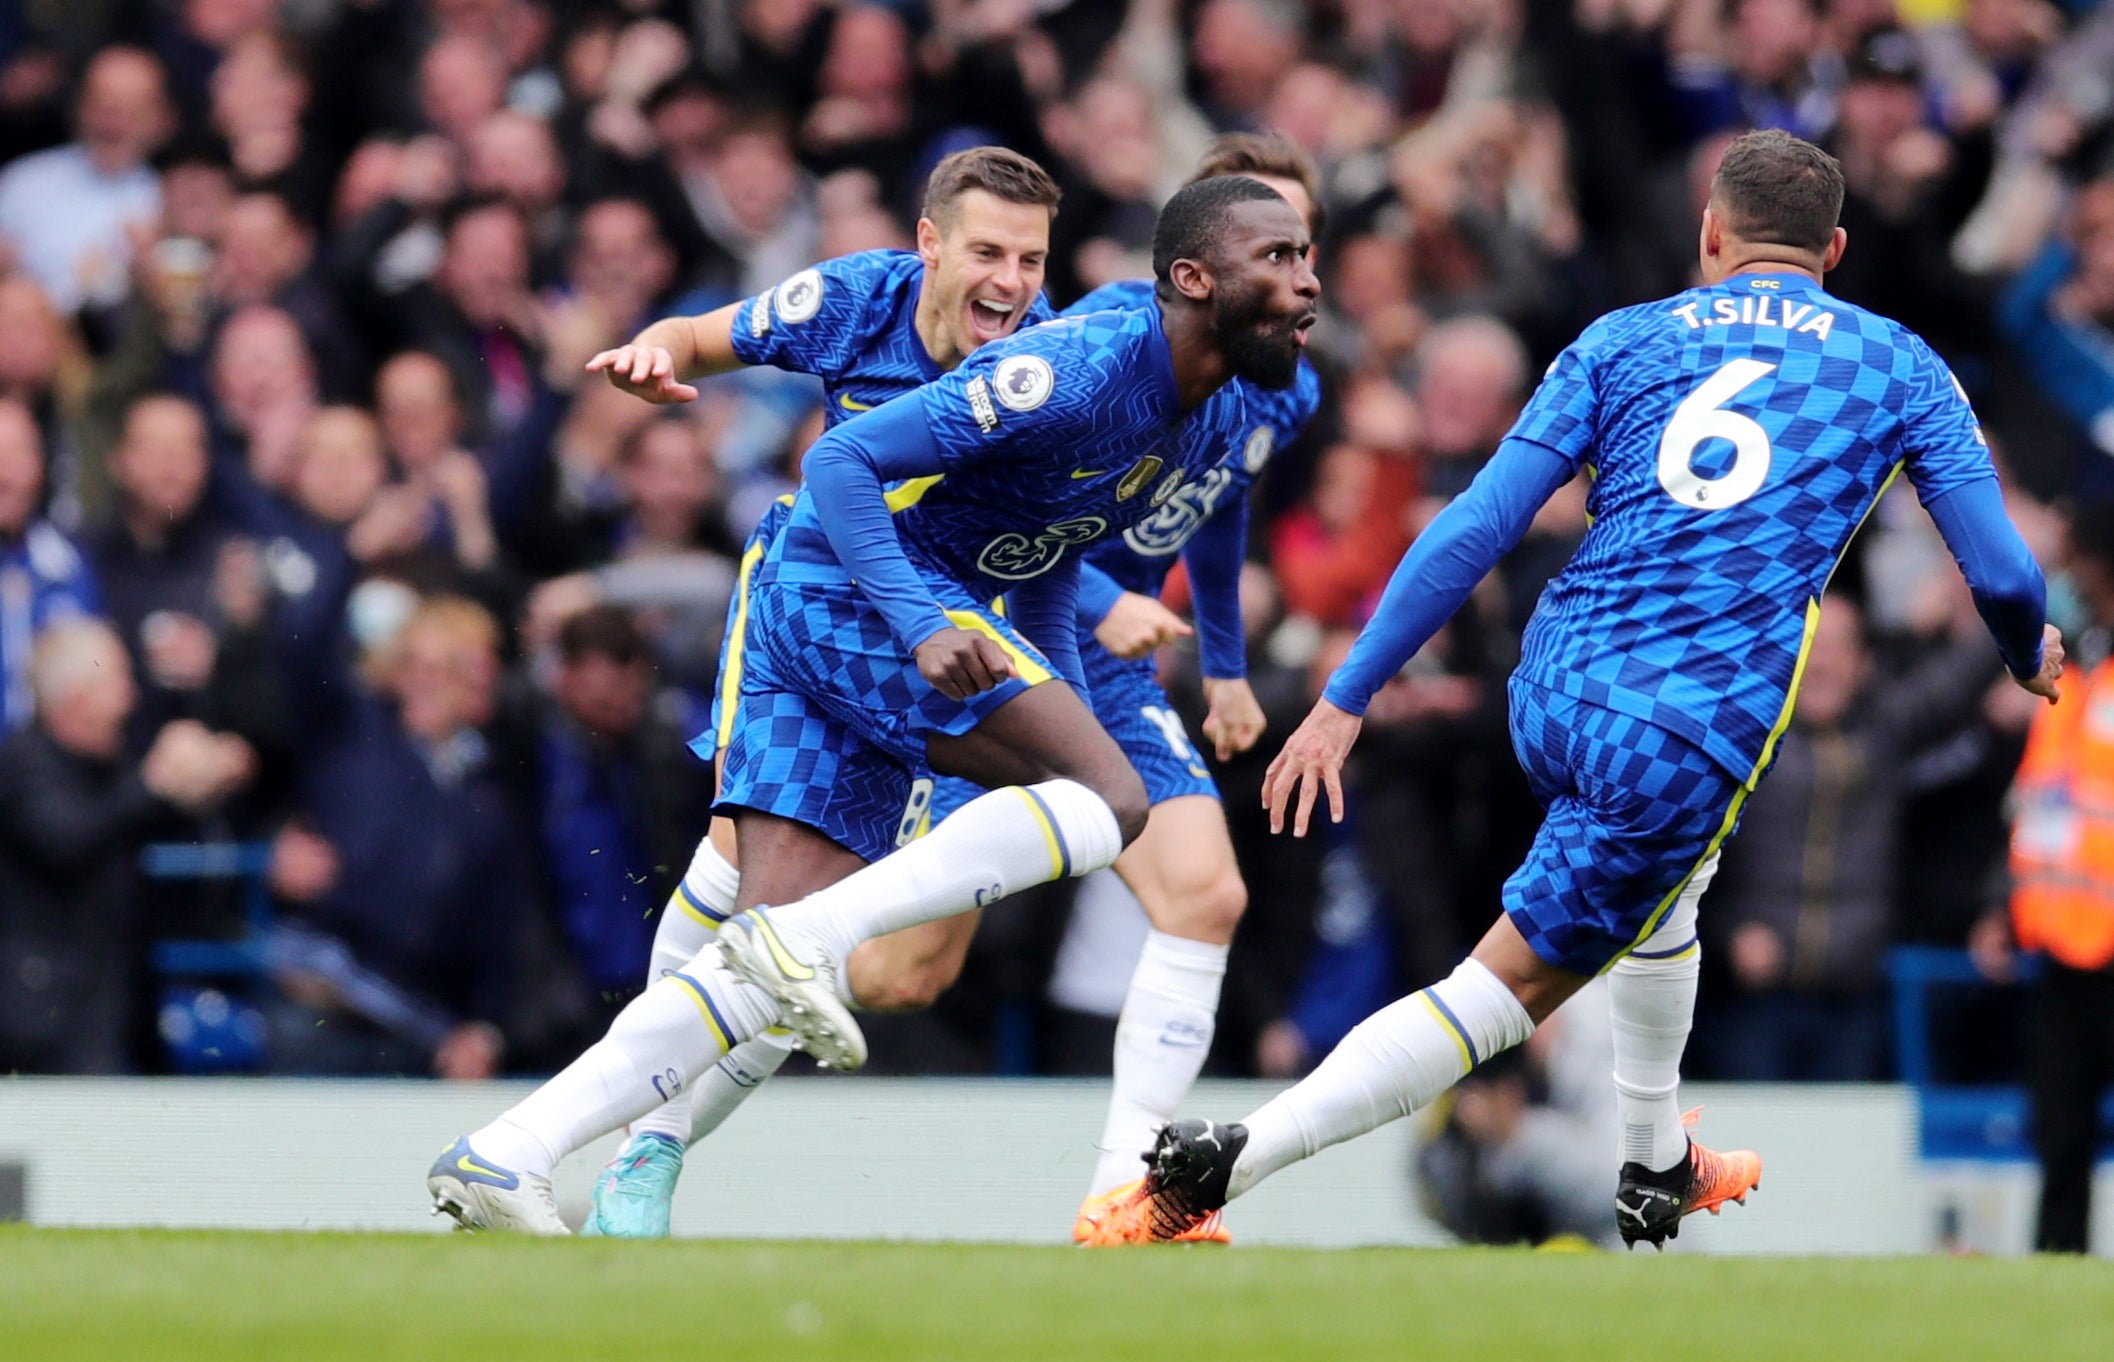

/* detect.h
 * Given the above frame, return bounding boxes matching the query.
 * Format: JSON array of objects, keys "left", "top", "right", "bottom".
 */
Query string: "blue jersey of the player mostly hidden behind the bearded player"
[{"left": 1063, "top": 279, "right": 1321, "bottom": 596}]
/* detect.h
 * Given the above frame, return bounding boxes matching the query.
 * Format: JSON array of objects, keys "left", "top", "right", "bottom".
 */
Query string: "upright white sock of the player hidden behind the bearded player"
[{"left": 1087, "top": 933, "right": 1228, "bottom": 1195}]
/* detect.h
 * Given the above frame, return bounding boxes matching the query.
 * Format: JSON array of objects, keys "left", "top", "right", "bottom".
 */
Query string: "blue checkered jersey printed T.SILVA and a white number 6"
[{"left": 1512, "top": 273, "right": 1994, "bottom": 778}]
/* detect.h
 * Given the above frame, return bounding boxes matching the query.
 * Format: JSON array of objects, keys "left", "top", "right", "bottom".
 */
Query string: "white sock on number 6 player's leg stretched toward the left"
[{"left": 1226, "top": 960, "right": 1535, "bottom": 1197}]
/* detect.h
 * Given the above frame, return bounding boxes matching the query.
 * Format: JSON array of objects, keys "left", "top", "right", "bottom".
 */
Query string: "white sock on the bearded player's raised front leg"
[{"left": 769, "top": 780, "right": 1123, "bottom": 972}]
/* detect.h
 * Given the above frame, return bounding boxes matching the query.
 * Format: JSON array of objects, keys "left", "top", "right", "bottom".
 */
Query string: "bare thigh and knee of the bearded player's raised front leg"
[{"left": 926, "top": 681, "right": 1148, "bottom": 842}]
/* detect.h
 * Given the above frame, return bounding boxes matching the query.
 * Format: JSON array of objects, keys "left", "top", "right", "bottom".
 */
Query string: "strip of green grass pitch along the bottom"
[{"left": 0, "top": 1229, "right": 2114, "bottom": 1362}]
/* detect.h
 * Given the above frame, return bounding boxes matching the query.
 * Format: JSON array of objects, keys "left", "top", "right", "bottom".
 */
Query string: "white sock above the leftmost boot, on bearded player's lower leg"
[{"left": 469, "top": 952, "right": 778, "bottom": 1176}]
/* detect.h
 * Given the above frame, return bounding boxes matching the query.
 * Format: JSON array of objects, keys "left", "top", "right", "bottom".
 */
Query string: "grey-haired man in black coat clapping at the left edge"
[{"left": 0, "top": 620, "right": 256, "bottom": 1074}]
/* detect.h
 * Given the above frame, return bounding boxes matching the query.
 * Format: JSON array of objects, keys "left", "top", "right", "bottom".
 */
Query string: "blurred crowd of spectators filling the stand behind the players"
[{"left": 0, "top": 0, "right": 2114, "bottom": 1125}]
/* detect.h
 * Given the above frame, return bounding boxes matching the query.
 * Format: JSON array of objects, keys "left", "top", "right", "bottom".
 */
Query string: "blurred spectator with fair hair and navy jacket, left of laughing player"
[{"left": 273, "top": 599, "right": 533, "bottom": 1079}]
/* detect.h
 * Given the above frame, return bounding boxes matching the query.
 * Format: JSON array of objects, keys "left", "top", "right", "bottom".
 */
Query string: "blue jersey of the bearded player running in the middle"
[{"left": 769, "top": 307, "right": 1247, "bottom": 596}]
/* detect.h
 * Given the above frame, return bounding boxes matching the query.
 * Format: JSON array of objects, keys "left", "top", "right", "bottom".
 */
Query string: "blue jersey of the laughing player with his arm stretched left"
[{"left": 734, "top": 250, "right": 1055, "bottom": 425}]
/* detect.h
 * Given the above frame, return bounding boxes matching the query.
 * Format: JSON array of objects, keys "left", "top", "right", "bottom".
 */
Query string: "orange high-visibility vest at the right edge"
[{"left": 2010, "top": 660, "right": 2114, "bottom": 969}]
